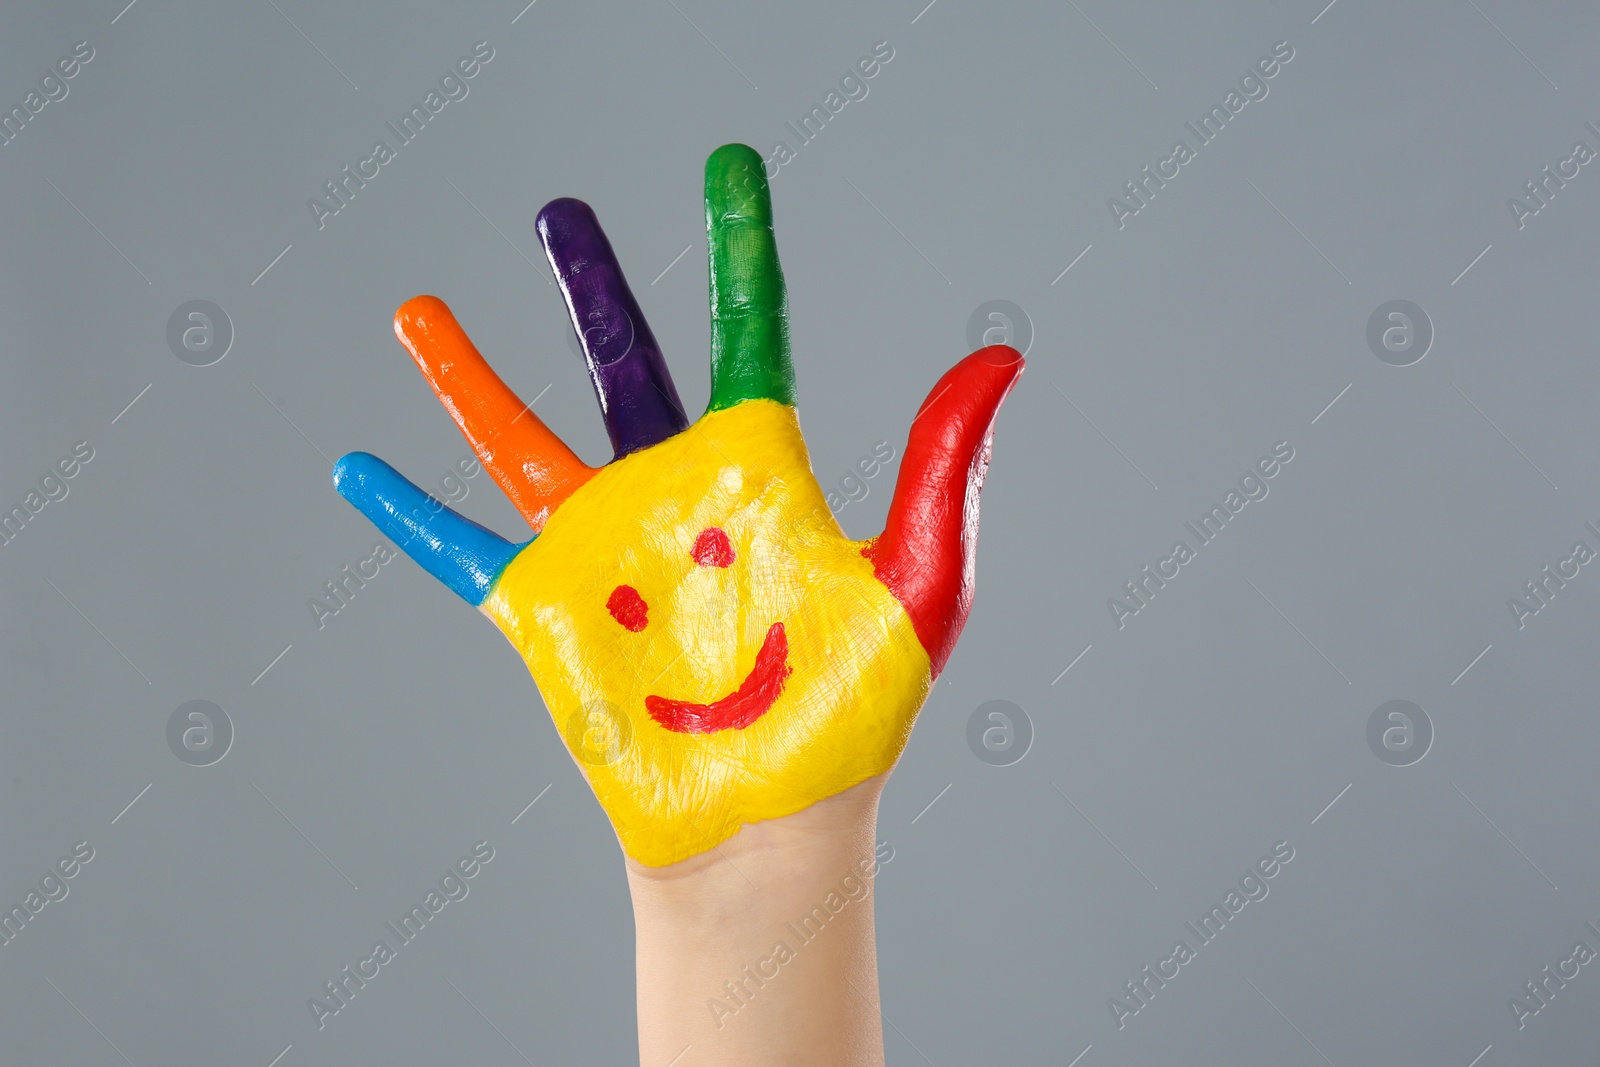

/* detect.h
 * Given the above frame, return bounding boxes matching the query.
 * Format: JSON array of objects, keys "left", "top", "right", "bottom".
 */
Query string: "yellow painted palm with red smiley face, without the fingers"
[{"left": 482, "top": 400, "right": 931, "bottom": 865}]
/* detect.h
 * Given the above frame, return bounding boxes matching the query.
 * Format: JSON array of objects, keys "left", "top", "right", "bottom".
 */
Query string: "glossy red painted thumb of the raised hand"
[{"left": 862, "top": 344, "right": 1022, "bottom": 677}]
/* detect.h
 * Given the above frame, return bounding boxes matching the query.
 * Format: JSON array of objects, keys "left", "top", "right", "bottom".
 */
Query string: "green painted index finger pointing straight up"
[{"left": 706, "top": 144, "right": 795, "bottom": 411}]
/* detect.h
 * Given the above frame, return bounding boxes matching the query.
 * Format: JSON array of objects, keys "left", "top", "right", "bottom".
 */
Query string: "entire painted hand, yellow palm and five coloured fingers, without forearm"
[{"left": 333, "top": 144, "right": 1022, "bottom": 865}]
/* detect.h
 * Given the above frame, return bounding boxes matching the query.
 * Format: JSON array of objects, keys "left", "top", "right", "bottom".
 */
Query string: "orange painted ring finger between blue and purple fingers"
[{"left": 395, "top": 296, "right": 595, "bottom": 533}]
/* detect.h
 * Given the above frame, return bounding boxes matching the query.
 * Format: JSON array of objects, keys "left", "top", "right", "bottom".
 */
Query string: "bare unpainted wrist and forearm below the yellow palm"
[{"left": 629, "top": 777, "right": 886, "bottom": 1067}]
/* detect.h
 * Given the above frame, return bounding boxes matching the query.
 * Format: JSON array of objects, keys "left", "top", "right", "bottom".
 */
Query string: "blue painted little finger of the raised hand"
[{"left": 333, "top": 453, "right": 526, "bottom": 606}]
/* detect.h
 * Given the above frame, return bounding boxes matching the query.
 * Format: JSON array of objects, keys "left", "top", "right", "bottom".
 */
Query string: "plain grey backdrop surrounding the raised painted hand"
[{"left": 0, "top": 0, "right": 1600, "bottom": 1067}]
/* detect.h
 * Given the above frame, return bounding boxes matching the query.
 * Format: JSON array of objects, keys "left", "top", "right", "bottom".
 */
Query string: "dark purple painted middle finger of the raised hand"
[{"left": 536, "top": 197, "right": 690, "bottom": 458}]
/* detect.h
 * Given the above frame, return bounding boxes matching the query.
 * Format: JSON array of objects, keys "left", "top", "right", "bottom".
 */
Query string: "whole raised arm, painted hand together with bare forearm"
[{"left": 334, "top": 146, "right": 1022, "bottom": 1067}]
